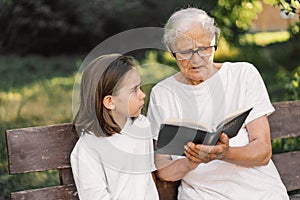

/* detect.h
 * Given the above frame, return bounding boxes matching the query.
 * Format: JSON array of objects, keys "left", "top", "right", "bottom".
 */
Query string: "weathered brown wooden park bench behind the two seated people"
[{"left": 5, "top": 101, "right": 300, "bottom": 200}]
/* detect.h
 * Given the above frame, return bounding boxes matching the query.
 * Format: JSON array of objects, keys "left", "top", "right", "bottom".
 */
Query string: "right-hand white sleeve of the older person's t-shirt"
[{"left": 245, "top": 65, "right": 275, "bottom": 124}]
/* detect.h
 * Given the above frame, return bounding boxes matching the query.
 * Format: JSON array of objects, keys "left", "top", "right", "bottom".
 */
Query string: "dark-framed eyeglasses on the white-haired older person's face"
[{"left": 172, "top": 45, "right": 217, "bottom": 60}]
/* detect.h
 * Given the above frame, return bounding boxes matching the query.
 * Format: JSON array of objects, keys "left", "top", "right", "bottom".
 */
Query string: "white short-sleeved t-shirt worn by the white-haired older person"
[{"left": 147, "top": 62, "right": 288, "bottom": 200}]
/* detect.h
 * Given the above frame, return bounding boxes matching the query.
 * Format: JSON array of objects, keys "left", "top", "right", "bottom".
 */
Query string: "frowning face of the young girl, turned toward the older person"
[{"left": 112, "top": 68, "right": 146, "bottom": 122}]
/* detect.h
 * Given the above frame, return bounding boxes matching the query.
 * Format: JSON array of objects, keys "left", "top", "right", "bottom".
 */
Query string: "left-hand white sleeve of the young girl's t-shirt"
[{"left": 71, "top": 139, "right": 110, "bottom": 200}]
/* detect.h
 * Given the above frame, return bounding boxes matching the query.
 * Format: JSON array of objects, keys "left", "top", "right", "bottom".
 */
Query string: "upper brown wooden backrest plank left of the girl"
[{"left": 6, "top": 123, "right": 78, "bottom": 174}]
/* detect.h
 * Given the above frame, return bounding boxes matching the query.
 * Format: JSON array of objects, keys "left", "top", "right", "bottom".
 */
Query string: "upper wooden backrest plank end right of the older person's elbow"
[{"left": 269, "top": 101, "right": 300, "bottom": 139}]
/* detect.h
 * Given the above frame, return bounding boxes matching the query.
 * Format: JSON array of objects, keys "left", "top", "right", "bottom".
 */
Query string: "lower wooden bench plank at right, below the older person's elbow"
[{"left": 272, "top": 151, "right": 300, "bottom": 191}]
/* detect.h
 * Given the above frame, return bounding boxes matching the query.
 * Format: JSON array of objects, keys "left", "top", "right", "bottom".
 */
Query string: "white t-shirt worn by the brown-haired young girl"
[{"left": 71, "top": 115, "right": 159, "bottom": 200}]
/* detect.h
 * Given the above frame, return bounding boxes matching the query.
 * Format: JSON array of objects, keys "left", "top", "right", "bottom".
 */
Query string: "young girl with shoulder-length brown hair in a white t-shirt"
[{"left": 71, "top": 54, "right": 158, "bottom": 200}]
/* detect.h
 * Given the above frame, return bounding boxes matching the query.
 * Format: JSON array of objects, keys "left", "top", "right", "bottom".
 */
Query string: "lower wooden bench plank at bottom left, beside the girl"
[{"left": 10, "top": 185, "right": 79, "bottom": 200}]
